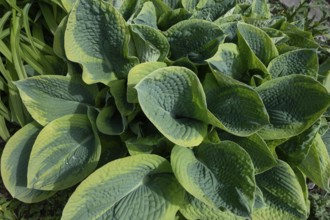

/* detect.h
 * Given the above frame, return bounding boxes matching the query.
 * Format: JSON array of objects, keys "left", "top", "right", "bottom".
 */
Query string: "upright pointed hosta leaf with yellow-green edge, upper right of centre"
[{"left": 237, "top": 22, "right": 278, "bottom": 65}]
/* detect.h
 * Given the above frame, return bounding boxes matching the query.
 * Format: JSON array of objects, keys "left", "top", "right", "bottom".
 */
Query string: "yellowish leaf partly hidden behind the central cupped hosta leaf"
[{"left": 127, "top": 62, "right": 166, "bottom": 103}]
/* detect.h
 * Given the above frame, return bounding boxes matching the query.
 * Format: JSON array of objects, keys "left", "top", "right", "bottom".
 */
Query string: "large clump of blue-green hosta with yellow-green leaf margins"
[{"left": 1, "top": 0, "right": 330, "bottom": 220}]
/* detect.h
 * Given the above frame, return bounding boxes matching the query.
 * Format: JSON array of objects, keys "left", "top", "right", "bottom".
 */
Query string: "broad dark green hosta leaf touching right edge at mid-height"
[{"left": 256, "top": 75, "right": 330, "bottom": 139}]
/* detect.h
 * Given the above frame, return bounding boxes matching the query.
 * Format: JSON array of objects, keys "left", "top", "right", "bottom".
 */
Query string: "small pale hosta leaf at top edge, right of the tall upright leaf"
[{"left": 133, "top": 1, "right": 158, "bottom": 29}]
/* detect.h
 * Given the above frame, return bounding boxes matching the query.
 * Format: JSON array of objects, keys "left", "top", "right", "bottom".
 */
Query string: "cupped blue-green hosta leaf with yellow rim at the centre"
[{"left": 135, "top": 67, "right": 208, "bottom": 147}]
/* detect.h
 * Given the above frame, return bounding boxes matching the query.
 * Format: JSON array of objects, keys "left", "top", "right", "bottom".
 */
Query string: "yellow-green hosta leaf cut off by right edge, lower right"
[{"left": 298, "top": 134, "right": 330, "bottom": 192}]
